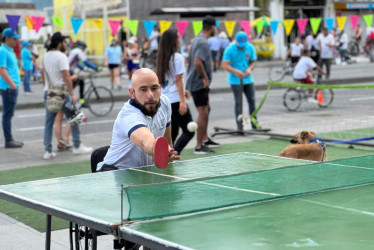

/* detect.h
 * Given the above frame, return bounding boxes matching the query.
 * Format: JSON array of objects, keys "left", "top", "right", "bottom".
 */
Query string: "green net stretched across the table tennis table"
[{"left": 124, "top": 156, "right": 374, "bottom": 221}]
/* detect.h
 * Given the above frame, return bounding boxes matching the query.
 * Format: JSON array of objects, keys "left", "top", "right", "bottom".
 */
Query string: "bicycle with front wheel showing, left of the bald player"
[{"left": 77, "top": 69, "right": 114, "bottom": 117}]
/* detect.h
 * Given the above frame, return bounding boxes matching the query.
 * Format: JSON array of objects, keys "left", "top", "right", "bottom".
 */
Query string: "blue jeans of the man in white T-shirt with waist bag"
[{"left": 44, "top": 91, "right": 81, "bottom": 153}]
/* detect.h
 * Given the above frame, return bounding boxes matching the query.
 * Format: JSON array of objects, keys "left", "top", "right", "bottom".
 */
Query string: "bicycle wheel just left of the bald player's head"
[{"left": 87, "top": 86, "right": 114, "bottom": 116}]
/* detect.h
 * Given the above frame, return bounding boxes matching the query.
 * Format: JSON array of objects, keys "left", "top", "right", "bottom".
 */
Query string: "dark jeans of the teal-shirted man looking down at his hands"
[{"left": 230, "top": 83, "right": 256, "bottom": 130}]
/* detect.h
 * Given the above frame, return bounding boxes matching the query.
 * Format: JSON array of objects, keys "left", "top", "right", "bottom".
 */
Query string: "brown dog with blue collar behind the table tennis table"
[{"left": 279, "top": 130, "right": 327, "bottom": 161}]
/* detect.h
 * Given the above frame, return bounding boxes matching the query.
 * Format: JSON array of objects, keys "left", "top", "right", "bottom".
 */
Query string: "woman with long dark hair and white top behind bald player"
[{"left": 156, "top": 29, "right": 195, "bottom": 154}]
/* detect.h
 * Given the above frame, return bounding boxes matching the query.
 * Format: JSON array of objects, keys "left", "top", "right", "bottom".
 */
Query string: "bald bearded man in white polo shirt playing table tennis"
[{"left": 97, "top": 68, "right": 180, "bottom": 171}]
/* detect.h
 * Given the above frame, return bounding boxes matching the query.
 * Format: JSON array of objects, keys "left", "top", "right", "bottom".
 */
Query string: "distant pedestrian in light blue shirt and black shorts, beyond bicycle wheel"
[{"left": 104, "top": 40, "right": 123, "bottom": 90}]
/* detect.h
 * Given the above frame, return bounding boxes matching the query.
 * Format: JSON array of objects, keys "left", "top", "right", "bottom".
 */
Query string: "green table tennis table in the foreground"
[{"left": 0, "top": 153, "right": 374, "bottom": 249}]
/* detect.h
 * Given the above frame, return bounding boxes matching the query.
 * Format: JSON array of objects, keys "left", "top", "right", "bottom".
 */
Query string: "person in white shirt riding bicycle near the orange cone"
[{"left": 293, "top": 49, "right": 326, "bottom": 103}]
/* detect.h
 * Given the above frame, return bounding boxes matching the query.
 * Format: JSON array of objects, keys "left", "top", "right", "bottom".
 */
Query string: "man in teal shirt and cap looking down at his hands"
[{"left": 222, "top": 32, "right": 257, "bottom": 131}]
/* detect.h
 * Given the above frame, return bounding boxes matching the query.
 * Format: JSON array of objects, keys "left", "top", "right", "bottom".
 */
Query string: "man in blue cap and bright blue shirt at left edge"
[{"left": 0, "top": 28, "right": 23, "bottom": 148}]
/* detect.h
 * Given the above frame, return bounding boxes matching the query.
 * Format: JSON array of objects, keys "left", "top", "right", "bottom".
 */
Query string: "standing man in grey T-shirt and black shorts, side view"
[{"left": 186, "top": 16, "right": 219, "bottom": 154}]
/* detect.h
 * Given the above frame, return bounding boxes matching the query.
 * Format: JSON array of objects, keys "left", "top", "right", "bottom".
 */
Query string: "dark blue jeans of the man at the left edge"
[{"left": 0, "top": 88, "right": 18, "bottom": 141}]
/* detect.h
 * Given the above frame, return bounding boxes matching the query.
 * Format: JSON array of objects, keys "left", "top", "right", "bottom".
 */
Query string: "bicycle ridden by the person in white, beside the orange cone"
[{"left": 283, "top": 87, "right": 334, "bottom": 111}]
